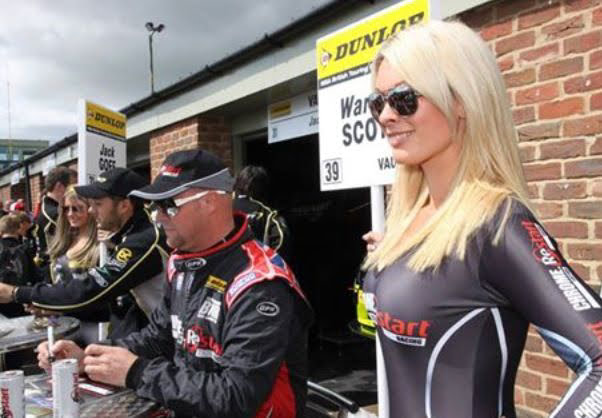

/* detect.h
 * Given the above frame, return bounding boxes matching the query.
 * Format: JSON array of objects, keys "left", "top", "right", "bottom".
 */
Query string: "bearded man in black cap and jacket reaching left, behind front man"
[{"left": 0, "top": 168, "right": 167, "bottom": 338}]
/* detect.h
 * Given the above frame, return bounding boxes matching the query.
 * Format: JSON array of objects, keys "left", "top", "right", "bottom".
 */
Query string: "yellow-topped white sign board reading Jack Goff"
[{"left": 77, "top": 99, "right": 126, "bottom": 184}]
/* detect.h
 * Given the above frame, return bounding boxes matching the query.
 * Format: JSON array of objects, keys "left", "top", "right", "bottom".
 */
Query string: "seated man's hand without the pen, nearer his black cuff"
[{"left": 84, "top": 344, "right": 138, "bottom": 387}]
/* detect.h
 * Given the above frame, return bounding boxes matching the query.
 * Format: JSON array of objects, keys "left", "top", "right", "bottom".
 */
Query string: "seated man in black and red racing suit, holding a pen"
[{"left": 38, "top": 151, "right": 312, "bottom": 418}]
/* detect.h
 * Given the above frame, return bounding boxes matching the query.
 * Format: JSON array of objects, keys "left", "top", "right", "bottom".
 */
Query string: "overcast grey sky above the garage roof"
[{"left": 0, "top": 0, "right": 329, "bottom": 141}]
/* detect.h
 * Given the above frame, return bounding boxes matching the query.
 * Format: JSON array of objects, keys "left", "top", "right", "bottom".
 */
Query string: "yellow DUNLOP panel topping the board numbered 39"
[{"left": 316, "top": 0, "right": 430, "bottom": 80}]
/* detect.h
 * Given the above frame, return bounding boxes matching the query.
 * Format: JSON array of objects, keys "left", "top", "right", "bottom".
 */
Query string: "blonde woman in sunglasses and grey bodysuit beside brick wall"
[{"left": 364, "top": 21, "right": 602, "bottom": 418}]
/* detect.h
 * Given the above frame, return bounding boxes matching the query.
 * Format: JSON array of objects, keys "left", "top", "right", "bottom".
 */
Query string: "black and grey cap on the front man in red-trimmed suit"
[{"left": 130, "top": 150, "right": 234, "bottom": 200}]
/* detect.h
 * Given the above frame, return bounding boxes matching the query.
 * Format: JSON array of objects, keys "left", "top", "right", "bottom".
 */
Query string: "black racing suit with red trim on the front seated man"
[{"left": 118, "top": 214, "right": 312, "bottom": 418}]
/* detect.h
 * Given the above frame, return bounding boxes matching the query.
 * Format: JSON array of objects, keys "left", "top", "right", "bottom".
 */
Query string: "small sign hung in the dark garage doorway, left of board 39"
[{"left": 268, "top": 91, "right": 318, "bottom": 144}]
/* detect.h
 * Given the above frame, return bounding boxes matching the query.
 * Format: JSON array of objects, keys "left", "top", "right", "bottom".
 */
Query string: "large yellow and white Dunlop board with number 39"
[{"left": 316, "top": 0, "right": 432, "bottom": 190}]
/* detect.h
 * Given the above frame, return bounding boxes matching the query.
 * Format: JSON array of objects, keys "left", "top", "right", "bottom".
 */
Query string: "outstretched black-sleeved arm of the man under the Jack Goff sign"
[{"left": 10, "top": 225, "right": 163, "bottom": 312}]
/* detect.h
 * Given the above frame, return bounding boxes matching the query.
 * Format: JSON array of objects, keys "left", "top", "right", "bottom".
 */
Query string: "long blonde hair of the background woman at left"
[{"left": 48, "top": 186, "right": 99, "bottom": 268}]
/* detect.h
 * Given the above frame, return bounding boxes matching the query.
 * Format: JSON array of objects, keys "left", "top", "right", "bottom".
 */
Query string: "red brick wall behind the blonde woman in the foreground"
[{"left": 461, "top": 0, "right": 602, "bottom": 417}]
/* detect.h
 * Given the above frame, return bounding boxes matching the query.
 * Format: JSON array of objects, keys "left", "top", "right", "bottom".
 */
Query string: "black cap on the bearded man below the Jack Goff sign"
[{"left": 75, "top": 167, "right": 148, "bottom": 199}]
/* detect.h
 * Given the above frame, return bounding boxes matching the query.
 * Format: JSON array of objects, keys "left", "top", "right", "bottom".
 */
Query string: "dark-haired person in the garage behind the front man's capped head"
[{"left": 234, "top": 165, "right": 291, "bottom": 261}]
